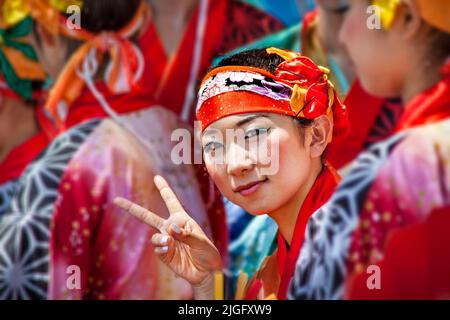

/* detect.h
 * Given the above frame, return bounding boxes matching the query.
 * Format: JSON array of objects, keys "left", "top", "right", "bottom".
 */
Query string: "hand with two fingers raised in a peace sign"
[{"left": 114, "top": 176, "right": 222, "bottom": 285}]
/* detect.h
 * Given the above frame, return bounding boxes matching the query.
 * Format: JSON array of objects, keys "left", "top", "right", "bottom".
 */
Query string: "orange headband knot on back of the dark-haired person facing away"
[{"left": 28, "top": 0, "right": 149, "bottom": 121}]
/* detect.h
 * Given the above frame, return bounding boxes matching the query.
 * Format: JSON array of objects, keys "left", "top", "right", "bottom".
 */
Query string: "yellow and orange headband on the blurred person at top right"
[{"left": 372, "top": 0, "right": 450, "bottom": 33}]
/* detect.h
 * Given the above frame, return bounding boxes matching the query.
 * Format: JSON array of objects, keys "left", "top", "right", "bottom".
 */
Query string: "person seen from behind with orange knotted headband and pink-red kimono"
[{"left": 0, "top": 0, "right": 226, "bottom": 299}]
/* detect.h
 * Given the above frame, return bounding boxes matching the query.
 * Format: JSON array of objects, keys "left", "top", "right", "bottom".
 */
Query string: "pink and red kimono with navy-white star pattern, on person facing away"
[{"left": 0, "top": 84, "right": 220, "bottom": 299}]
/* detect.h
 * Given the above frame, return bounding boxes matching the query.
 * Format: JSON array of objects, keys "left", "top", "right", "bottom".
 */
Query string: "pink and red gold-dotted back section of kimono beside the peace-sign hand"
[{"left": 49, "top": 108, "right": 211, "bottom": 299}]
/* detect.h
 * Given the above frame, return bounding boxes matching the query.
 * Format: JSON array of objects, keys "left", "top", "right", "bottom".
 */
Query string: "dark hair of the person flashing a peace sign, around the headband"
[{"left": 216, "top": 48, "right": 313, "bottom": 128}]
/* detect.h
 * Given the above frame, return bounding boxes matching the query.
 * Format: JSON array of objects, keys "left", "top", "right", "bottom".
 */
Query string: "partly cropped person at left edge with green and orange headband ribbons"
[{"left": 0, "top": 14, "right": 52, "bottom": 216}]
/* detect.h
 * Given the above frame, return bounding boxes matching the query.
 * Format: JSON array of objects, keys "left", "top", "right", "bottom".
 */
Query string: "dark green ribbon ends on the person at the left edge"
[{"left": 0, "top": 18, "right": 37, "bottom": 100}]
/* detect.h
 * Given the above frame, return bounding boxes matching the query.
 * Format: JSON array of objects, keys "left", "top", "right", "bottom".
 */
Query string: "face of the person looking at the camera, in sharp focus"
[{"left": 202, "top": 113, "right": 332, "bottom": 215}]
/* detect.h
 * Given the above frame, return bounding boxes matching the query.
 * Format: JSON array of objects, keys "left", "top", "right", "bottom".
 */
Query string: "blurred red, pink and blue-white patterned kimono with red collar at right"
[{"left": 290, "top": 64, "right": 450, "bottom": 299}]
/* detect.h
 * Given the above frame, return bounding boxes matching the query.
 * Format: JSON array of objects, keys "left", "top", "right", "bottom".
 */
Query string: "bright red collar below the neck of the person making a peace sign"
[{"left": 246, "top": 165, "right": 339, "bottom": 300}]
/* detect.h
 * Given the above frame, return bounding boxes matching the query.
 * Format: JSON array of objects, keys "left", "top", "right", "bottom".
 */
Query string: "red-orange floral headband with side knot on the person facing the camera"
[{"left": 197, "top": 48, "right": 348, "bottom": 141}]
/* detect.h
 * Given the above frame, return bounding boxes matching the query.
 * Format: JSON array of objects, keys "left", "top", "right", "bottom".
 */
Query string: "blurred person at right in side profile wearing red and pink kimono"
[{"left": 290, "top": 0, "right": 450, "bottom": 299}]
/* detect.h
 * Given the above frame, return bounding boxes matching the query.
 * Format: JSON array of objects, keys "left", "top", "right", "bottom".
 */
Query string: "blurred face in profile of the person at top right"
[{"left": 340, "top": 0, "right": 425, "bottom": 97}]
